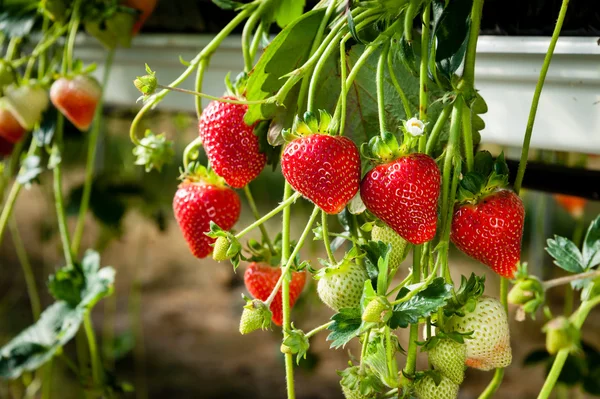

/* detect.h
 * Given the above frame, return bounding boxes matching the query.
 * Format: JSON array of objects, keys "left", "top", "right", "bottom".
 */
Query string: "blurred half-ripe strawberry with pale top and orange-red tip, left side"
[{"left": 50, "top": 75, "right": 102, "bottom": 131}]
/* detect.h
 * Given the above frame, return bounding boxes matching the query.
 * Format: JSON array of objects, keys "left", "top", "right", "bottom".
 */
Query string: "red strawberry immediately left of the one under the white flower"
[{"left": 281, "top": 134, "right": 360, "bottom": 214}]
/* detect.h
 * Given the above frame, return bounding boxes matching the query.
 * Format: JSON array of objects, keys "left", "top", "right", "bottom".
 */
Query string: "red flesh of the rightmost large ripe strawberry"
[{"left": 450, "top": 190, "right": 525, "bottom": 278}]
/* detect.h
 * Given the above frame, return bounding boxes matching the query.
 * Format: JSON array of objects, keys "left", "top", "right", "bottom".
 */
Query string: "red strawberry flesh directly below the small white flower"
[{"left": 360, "top": 154, "right": 441, "bottom": 244}]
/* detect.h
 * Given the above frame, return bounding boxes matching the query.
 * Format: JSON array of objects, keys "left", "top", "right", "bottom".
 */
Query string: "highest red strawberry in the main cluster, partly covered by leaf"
[{"left": 198, "top": 97, "right": 267, "bottom": 188}]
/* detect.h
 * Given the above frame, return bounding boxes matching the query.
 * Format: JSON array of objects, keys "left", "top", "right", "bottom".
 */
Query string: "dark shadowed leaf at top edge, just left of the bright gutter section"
[{"left": 432, "top": 0, "right": 473, "bottom": 81}]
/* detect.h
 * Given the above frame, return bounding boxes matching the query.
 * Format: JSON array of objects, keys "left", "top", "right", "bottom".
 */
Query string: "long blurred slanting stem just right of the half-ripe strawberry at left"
[{"left": 71, "top": 49, "right": 115, "bottom": 255}]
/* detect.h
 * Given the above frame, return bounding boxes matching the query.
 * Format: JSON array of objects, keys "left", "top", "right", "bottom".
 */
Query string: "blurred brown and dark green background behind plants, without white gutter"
[{"left": 0, "top": 0, "right": 600, "bottom": 399}]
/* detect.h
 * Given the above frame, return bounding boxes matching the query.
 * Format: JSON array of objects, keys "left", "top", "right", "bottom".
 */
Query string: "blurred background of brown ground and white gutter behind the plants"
[{"left": 0, "top": 0, "right": 600, "bottom": 399}]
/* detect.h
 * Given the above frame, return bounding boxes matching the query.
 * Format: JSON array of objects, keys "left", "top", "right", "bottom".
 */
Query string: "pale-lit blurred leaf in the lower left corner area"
[{"left": 0, "top": 250, "right": 115, "bottom": 379}]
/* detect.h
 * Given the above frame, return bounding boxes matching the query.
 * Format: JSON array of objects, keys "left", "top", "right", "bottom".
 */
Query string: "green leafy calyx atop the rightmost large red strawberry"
[{"left": 457, "top": 151, "right": 509, "bottom": 204}]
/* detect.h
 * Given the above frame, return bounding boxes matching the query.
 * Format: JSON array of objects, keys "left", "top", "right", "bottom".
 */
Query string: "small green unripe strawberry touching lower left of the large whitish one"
[{"left": 429, "top": 338, "right": 467, "bottom": 385}]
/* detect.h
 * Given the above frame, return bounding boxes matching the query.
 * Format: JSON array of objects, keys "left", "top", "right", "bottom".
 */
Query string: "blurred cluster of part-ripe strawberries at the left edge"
[{"left": 0, "top": 74, "right": 102, "bottom": 156}]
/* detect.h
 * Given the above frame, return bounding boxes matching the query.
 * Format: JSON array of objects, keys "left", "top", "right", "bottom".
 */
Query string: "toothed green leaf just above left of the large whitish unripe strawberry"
[{"left": 390, "top": 277, "right": 452, "bottom": 328}]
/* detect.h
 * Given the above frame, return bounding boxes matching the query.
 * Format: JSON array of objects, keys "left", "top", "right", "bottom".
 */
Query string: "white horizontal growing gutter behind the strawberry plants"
[{"left": 76, "top": 35, "right": 600, "bottom": 154}]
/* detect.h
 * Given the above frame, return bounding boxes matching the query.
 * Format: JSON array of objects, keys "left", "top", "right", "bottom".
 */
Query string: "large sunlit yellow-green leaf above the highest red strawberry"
[{"left": 244, "top": 9, "right": 325, "bottom": 125}]
